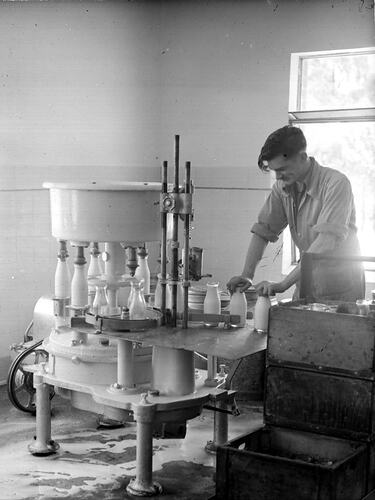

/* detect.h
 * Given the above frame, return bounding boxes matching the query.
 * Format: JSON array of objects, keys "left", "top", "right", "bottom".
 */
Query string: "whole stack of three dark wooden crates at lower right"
[{"left": 216, "top": 304, "right": 375, "bottom": 500}]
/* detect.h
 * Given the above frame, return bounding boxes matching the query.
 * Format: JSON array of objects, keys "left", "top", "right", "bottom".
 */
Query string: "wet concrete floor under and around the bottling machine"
[{"left": 0, "top": 387, "right": 262, "bottom": 500}]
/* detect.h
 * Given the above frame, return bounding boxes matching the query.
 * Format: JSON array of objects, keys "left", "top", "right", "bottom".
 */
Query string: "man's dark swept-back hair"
[{"left": 258, "top": 125, "right": 306, "bottom": 171}]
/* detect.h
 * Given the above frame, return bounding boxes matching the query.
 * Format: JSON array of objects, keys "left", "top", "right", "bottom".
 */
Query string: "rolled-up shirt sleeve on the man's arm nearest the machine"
[{"left": 251, "top": 186, "right": 288, "bottom": 242}]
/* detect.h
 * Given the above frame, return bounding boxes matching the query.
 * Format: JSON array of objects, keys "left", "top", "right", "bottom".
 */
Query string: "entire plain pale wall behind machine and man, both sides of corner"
[{"left": 0, "top": 0, "right": 374, "bottom": 380}]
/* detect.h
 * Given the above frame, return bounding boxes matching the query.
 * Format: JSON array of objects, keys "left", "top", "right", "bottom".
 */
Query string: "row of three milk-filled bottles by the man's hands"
[{"left": 203, "top": 283, "right": 271, "bottom": 332}]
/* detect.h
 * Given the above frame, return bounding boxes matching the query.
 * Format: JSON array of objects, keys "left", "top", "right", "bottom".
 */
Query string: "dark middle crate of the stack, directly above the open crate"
[{"left": 264, "top": 365, "right": 374, "bottom": 440}]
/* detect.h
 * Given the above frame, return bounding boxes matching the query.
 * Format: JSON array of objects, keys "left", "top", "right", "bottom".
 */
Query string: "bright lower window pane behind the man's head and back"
[{"left": 301, "top": 122, "right": 375, "bottom": 267}]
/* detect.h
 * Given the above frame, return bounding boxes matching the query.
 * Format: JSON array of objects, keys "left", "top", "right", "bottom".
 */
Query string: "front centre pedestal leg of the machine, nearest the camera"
[{"left": 126, "top": 394, "right": 162, "bottom": 497}]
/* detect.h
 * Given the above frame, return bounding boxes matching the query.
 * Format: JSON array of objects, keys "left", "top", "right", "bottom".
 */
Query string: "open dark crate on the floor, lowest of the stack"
[{"left": 215, "top": 426, "right": 368, "bottom": 500}]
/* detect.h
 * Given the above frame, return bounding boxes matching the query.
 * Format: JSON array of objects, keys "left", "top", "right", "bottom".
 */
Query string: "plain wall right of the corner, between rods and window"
[{"left": 161, "top": 0, "right": 375, "bottom": 286}]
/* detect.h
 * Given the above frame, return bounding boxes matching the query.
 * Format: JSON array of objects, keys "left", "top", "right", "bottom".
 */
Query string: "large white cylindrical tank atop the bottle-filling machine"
[{"left": 43, "top": 182, "right": 161, "bottom": 242}]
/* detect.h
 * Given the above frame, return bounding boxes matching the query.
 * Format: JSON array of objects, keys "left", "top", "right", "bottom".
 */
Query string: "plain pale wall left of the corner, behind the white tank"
[{"left": 0, "top": 1, "right": 161, "bottom": 380}]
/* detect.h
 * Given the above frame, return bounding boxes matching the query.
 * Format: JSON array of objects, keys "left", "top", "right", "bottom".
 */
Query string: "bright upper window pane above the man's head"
[{"left": 300, "top": 53, "right": 375, "bottom": 111}]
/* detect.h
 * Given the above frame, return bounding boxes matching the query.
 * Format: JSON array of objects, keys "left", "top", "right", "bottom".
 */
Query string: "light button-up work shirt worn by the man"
[{"left": 251, "top": 158, "right": 363, "bottom": 298}]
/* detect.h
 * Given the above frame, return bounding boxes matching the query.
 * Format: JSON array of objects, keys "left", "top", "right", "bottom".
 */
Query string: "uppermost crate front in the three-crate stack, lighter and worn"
[{"left": 267, "top": 304, "right": 375, "bottom": 380}]
